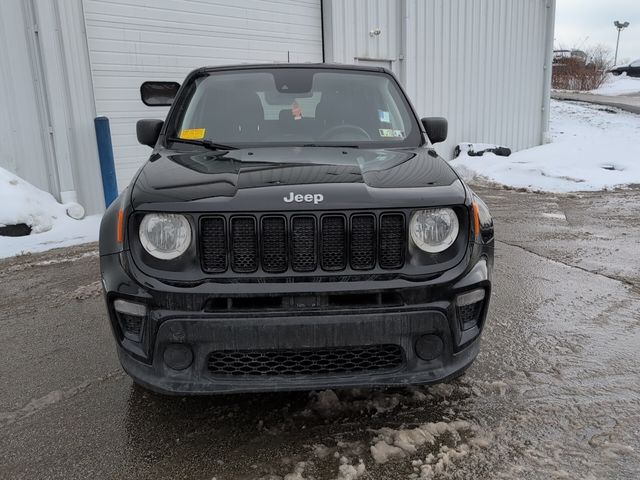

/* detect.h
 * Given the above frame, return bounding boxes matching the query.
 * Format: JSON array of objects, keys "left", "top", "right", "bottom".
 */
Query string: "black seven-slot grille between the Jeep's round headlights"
[{"left": 200, "top": 212, "right": 406, "bottom": 273}]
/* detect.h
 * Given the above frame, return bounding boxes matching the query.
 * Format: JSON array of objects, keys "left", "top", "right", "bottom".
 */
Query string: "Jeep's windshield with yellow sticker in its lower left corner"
[{"left": 169, "top": 67, "right": 422, "bottom": 148}]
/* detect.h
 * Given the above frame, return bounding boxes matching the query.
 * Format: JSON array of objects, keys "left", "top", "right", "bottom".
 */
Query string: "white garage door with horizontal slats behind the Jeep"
[{"left": 83, "top": 0, "right": 322, "bottom": 190}]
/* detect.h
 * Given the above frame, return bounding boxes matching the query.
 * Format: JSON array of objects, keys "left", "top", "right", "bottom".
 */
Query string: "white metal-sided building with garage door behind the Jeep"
[{"left": 0, "top": 0, "right": 555, "bottom": 212}]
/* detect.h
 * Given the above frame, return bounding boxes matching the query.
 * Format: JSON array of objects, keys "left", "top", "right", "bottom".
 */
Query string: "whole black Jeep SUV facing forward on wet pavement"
[{"left": 100, "top": 64, "right": 493, "bottom": 394}]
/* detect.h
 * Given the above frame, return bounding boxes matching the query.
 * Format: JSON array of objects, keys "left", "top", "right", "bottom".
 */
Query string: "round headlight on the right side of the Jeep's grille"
[{"left": 409, "top": 208, "right": 459, "bottom": 253}]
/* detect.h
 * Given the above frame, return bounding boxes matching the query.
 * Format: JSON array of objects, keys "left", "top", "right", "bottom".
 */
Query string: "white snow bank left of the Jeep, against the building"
[{"left": 0, "top": 168, "right": 101, "bottom": 258}]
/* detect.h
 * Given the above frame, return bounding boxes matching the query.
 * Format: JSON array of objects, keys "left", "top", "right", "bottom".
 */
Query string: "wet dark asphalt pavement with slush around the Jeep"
[{"left": 0, "top": 188, "right": 640, "bottom": 480}]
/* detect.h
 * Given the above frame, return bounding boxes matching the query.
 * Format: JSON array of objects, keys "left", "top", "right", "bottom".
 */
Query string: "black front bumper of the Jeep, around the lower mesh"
[{"left": 101, "top": 249, "right": 493, "bottom": 394}]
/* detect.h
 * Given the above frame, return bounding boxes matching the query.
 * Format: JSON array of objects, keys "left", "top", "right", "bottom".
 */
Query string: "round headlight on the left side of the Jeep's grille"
[{"left": 140, "top": 213, "right": 191, "bottom": 260}]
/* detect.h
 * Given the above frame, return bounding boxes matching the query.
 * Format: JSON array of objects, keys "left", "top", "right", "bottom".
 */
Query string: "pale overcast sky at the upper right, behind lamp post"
[{"left": 555, "top": 0, "right": 640, "bottom": 63}]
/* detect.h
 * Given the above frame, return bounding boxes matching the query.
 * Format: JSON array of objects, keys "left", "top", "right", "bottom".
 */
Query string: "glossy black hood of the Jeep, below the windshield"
[{"left": 131, "top": 147, "right": 465, "bottom": 211}]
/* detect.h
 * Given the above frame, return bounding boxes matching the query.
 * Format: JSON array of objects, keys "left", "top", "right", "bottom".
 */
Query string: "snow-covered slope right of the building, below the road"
[{"left": 451, "top": 100, "right": 640, "bottom": 192}]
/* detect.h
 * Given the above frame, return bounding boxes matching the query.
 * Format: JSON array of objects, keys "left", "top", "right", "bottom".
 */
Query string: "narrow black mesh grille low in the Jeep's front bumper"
[{"left": 208, "top": 345, "right": 405, "bottom": 376}]
